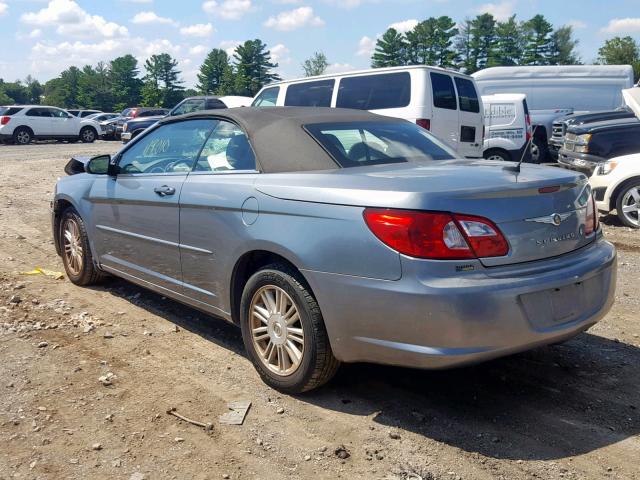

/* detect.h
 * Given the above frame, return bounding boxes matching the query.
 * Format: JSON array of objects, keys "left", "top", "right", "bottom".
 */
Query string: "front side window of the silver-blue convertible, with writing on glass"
[{"left": 118, "top": 120, "right": 217, "bottom": 175}]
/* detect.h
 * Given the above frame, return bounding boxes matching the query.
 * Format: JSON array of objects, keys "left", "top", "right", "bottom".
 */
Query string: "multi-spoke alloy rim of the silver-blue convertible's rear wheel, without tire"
[{"left": 249, "top": 285, "right": 304, "bottom": 376}]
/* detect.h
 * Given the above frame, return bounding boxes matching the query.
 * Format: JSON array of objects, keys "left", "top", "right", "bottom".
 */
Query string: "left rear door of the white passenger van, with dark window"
[{"left": 430, "top": 72, "right": 460, "bottom": 153}]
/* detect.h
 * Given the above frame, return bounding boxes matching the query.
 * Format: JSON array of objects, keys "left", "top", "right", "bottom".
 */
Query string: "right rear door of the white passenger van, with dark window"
[{"left": 454, "top": 77, "right": 484, "bottom": 157}]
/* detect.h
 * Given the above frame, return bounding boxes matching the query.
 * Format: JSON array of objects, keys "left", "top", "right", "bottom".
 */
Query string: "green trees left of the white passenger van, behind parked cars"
[{"left": 0, "top": 39, "right": 280, "bottom": 112}]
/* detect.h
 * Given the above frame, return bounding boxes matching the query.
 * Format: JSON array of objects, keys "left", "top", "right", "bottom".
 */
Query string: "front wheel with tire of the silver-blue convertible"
[{"left": 58, "top": 207, "right": 105, "bottom": 287}]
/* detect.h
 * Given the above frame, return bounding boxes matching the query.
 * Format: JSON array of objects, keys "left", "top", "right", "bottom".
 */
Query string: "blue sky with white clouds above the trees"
[{"left": 0, "top": 0, "right": 640, "bottom": 87}]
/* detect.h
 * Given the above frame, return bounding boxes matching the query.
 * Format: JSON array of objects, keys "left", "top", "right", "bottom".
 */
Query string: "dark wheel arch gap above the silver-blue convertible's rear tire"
[{"left": 229, "top": 249, "right": 315, "bottom": 325}]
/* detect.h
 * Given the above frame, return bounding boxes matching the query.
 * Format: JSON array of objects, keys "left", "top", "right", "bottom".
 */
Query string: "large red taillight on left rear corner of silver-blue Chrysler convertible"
[{"left": 363, "top": 208, "right": 509, "bottom": 260}]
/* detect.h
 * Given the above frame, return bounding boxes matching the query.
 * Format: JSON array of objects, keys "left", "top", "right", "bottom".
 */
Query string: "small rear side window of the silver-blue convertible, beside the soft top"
[{"left": 194, "top": 120, "right": 256, "bottom": 172}]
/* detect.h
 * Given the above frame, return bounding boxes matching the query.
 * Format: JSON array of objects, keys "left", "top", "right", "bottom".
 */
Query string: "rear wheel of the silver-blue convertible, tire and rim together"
[{"left": 240, "top": 264, "right": 340, "bottom": 394}]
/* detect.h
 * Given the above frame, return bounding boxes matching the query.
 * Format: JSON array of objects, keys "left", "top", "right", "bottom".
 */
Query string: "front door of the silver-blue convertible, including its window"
[{"left": 90, "top": 119, "right": 215, "bottom": 293}]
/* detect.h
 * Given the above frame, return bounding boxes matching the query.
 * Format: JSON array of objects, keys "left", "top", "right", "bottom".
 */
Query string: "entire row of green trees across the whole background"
[{"left": 0, "top": 13, "right": 640, "bottom": 111}]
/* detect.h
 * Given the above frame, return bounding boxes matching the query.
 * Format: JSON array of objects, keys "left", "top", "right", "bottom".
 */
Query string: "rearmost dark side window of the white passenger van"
[{"left": 336, "top": 72, "right": 411, "bottom": 110}]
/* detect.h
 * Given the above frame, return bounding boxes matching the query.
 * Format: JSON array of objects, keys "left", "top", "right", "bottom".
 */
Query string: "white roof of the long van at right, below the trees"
[{"left": 471, "top": 65, "right": 633, "bottom": 84}]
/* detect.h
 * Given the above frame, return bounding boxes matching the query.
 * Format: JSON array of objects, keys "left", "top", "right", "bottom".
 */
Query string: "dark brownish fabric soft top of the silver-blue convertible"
[{"left": 159, "top": 107, "right": 406, "bottom": 173}]
